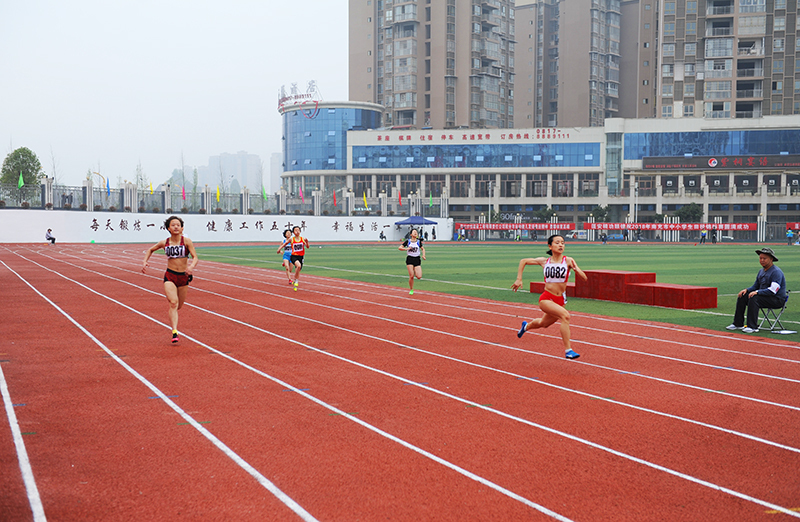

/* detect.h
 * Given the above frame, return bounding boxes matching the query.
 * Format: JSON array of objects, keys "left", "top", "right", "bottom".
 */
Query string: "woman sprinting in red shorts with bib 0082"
[{"left": 511, "top": 234, "right": 587, "bottom": 359}]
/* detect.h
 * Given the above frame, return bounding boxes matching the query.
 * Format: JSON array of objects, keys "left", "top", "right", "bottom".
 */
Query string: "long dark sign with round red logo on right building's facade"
[{"left": 642, "top": 154, "right": 800, "bottom": 171}]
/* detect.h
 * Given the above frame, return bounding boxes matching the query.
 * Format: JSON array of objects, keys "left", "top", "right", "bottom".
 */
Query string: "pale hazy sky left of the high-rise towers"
[{"left": 0, "top": 0, "right": 347, "bottom": 187}]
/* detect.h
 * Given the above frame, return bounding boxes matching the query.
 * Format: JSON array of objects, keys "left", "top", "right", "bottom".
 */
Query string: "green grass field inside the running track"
[{"left": 198, "top": 241, "right": 800, "bottom": 334}]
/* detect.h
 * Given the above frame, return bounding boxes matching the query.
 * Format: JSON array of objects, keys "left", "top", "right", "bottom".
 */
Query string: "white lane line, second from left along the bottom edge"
[{"left": 0, "top": 260, "right": 317, "bottom": 522}]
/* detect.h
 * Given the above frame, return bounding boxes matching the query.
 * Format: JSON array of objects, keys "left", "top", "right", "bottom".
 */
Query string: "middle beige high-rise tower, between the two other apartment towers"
[{"left": 514, "top": 0, "right": 639, "bottom": 127}]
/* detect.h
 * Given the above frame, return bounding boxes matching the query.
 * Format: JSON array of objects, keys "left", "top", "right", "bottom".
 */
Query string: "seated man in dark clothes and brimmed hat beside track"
[{"left": 726, "top": 248, "right": 787, "bottom": 333}]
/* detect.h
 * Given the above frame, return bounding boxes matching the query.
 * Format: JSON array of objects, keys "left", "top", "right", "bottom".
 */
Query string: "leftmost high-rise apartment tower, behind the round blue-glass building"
[{"left": 349, "top": 0, "right": 515, "bottom": 129}]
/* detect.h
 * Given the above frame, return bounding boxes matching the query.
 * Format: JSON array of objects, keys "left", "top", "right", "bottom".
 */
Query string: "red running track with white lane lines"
[{"left": 0, "top": 245, "right": 800, "bottom": 521}]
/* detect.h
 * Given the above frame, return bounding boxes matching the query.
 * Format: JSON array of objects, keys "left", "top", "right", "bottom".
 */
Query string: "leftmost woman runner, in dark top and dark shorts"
[{"left": 142, "top": 216, "right": 197, "bottom": 344}]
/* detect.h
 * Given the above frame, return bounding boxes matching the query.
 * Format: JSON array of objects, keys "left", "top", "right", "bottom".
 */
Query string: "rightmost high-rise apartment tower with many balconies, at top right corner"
[{"left": 652, "top": 0, "right": 800, "bottom": 118}]
